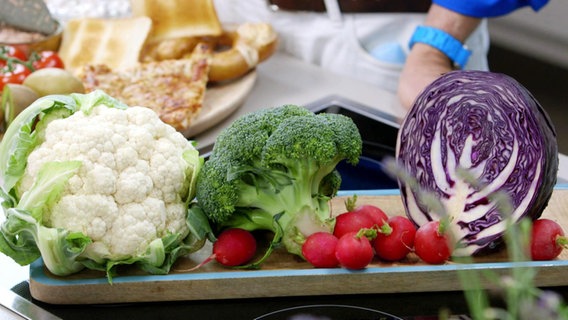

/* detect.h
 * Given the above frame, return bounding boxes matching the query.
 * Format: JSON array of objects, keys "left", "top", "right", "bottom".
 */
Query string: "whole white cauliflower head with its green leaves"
[{"left": 0, "top": 91, "right": 203, "bottom": 280}]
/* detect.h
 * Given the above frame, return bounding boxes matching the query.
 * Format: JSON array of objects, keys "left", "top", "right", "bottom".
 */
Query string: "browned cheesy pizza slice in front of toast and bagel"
[{"left": 80, "top": 45, "right": 212, "bottom": 133}]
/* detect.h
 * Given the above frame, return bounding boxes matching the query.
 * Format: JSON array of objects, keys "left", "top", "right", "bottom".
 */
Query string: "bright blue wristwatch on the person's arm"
[{"left": 408, "top": 26, "right": 471, "bottom": 69}]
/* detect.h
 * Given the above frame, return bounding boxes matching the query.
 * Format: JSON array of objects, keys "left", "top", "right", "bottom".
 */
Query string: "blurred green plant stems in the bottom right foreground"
[{"left": 384, "top": 159, "right": 568, "bottom": 320}]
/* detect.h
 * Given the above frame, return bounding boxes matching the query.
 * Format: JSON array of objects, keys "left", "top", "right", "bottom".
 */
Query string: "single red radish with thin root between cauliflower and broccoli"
[{"left": 189, "top": 228, "right": 256, "bottom": 271}]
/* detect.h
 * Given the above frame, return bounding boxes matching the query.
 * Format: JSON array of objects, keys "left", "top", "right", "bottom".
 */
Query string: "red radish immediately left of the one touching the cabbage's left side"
[{"left": 373, "top": 216, "right": 416, "bottom": 261}]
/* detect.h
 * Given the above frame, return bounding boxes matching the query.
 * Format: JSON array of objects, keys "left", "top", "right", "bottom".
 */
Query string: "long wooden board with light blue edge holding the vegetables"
[{"left": 30, "top": 186, "right": 568, "bottom": 304}]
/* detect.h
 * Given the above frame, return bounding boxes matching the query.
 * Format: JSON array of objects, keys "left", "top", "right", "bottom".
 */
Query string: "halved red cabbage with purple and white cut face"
[{"left": 396, "top": 71, "right": 558, "bottom": 256}]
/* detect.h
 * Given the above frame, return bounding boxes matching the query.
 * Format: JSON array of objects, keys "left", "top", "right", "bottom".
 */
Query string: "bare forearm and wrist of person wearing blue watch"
[{"left": 398, "top": 3, "right": 481, "bottom": 109}]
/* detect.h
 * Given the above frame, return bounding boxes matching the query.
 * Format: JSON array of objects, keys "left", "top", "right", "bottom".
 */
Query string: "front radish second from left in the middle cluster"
[{"left": 335, "top": 229, "right": 376, "bottom": 270}]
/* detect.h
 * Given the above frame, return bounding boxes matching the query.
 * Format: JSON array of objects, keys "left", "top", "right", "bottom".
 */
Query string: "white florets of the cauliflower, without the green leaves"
[{"left": 18, "top": 106, "right": 193, "bottom": 259}]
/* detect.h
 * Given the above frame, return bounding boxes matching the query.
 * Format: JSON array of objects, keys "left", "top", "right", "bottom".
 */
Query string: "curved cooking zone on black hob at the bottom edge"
[{"left": 255, "top": 304, "right": 402, "bottom": 320}]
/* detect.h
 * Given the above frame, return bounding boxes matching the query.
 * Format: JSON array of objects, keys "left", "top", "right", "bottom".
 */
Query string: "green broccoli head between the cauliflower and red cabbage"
[{"left": 196, "top": 105, "right": 362, "bottom": 264}]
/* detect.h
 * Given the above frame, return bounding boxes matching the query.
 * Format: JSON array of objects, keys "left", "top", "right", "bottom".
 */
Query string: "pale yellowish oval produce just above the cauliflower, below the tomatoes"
[{"left": 24, "top": 68, "right": 85, "bottom": 97}]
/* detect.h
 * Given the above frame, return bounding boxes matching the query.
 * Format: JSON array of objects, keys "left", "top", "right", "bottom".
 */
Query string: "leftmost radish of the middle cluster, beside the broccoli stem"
[{"left": 302, "top": 232, "right": 339, "bottom": 268}]
